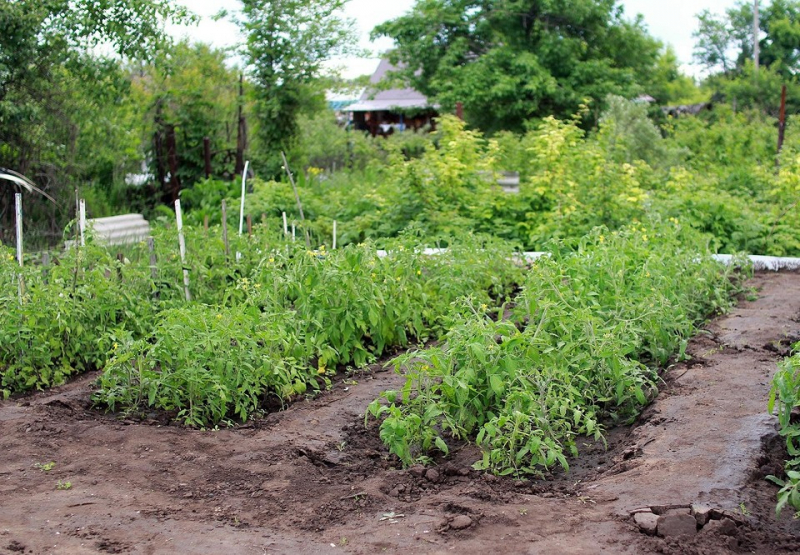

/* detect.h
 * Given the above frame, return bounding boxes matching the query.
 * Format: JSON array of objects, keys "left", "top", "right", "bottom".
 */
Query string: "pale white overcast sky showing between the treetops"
[{"left": 173, "top": 0, "right": 748, "bottom": 77}]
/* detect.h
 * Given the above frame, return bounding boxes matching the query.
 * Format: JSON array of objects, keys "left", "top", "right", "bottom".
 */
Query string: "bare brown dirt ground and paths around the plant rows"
[{"left": 0, "top": 273, "right": 800, "bottom": 555}]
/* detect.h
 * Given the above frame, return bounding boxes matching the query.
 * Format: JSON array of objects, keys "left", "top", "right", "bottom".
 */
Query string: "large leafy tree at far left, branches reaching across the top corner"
[{"left": 0, "top": 0, "right": 189, "bottom": 241}]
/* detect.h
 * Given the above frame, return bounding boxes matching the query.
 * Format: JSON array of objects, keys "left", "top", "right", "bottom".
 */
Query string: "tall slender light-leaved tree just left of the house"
[{"left": 240, "top": 0, "right": 355, "bottom": 173}]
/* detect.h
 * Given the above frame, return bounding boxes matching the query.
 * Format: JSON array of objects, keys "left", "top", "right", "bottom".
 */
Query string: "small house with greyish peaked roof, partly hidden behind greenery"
[{"left": 346, "top": 58, "right": 438, "bottom": 137}]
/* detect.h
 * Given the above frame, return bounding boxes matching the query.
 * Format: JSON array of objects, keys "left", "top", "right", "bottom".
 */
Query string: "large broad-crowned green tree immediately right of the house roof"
[{"left": 373, "top": 0, "right": 661, "bottom": 132}]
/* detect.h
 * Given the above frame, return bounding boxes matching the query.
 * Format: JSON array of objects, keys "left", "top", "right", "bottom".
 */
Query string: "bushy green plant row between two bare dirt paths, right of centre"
[{"left": 367, "top": 223, "right": 737, "bottom": 474}]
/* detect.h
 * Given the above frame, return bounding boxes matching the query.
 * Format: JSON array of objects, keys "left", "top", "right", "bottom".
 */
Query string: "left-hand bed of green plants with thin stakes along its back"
[{"left": 0, "top": 228, "right": 521, "bottom": 426}]
